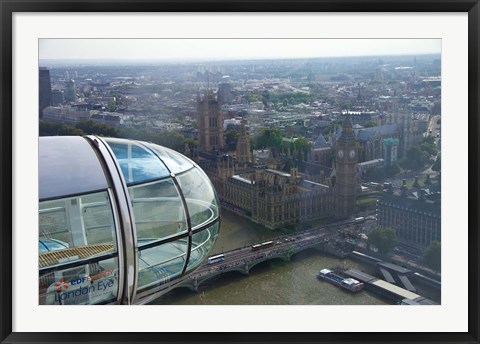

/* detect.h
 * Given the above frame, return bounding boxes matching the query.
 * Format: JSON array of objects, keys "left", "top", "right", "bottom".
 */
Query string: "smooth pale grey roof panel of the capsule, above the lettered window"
[{"left": 38, "top": 136, "right": 108, "bottom": 200}]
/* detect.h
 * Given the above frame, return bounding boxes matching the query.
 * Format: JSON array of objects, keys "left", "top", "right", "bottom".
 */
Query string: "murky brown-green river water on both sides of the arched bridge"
[{"left": 153, "top": 211, "right": 394, "bottom": 305}]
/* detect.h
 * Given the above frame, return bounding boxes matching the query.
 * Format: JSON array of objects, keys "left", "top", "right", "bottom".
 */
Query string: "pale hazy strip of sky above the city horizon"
[{"left": 39, "top": 39, "right": 441, "bottom": 60}]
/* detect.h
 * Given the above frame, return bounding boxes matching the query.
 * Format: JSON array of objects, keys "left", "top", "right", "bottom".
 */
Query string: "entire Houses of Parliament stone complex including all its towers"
[{"left": 195, "top": 90, "right": 358, "bottom": 229}]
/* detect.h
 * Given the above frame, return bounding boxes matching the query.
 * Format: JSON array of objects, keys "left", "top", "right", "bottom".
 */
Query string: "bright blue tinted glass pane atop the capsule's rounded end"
[{"left": 105, "top": 139, "right": 170, "bottom": 184}]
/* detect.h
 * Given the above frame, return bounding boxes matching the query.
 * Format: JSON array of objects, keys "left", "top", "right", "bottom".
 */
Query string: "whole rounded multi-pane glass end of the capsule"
[{"left": 105, "top": 138, "right": 219, "bottom": 292}]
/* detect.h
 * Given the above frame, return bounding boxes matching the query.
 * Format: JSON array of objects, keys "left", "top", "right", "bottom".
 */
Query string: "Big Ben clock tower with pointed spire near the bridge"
[{"left": 335, "top": 114, "right": 358, "bottom": 219}]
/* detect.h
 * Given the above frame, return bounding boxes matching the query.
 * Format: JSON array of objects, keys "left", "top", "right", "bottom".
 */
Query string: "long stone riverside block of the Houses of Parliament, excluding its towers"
[{"left": 202, "top": 155, "right": 335, "bottom": 229}]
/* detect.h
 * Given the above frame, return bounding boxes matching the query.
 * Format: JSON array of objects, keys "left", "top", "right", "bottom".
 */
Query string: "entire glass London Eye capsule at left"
[{"left": 38, "top": 136, "right": 220, "bottom": 305}]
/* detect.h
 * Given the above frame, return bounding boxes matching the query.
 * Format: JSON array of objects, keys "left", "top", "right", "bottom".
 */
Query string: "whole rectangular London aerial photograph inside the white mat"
[{"left": 38, "top": 38, "right": 442, "bottom": 306}]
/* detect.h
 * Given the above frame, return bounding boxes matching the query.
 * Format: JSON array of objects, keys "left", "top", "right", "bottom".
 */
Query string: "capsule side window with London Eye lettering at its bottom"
[{"left": 38, "top": 191, "right": 119, "bottom": 305}]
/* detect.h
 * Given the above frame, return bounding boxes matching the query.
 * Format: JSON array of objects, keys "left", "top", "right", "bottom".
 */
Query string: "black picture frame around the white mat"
[{"left": 0, "top": 0, "right": 480, "bottom": 343}]
